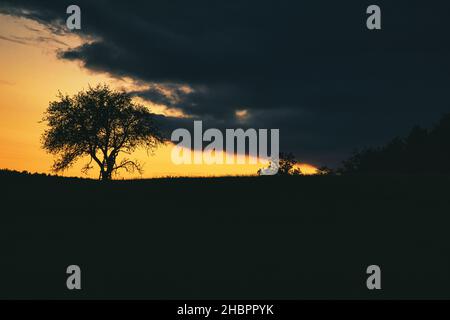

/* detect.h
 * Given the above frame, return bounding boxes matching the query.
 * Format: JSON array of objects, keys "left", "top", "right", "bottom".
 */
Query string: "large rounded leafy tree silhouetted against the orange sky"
[{"left": 42, "top": 85, "right": 164, "bottom": 180}]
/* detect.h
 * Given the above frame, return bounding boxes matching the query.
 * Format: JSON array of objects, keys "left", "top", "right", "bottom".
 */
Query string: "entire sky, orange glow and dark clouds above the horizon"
[{"left": 0, "top": 0, "right": 450, "bottom": 176}]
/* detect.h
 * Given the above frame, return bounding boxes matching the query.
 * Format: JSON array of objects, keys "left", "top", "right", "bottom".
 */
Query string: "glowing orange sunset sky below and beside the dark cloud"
[{"left": 0, "top": 11, "right": 315, "bottom": 178}]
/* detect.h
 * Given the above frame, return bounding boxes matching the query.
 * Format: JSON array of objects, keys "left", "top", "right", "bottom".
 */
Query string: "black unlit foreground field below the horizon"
[{"left": 0, "top": 172, "right": 450, "bottom": 299}]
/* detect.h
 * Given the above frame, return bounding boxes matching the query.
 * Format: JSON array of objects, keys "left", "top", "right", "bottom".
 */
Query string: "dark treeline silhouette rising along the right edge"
[{"left": 339, "top": 114, "right": 450, "bottom": 174}]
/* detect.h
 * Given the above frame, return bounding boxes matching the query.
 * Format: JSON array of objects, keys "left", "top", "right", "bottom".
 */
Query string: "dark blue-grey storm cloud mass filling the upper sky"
[{"left": 0, "top": 0, "right": 450, "bottom": 164}]
